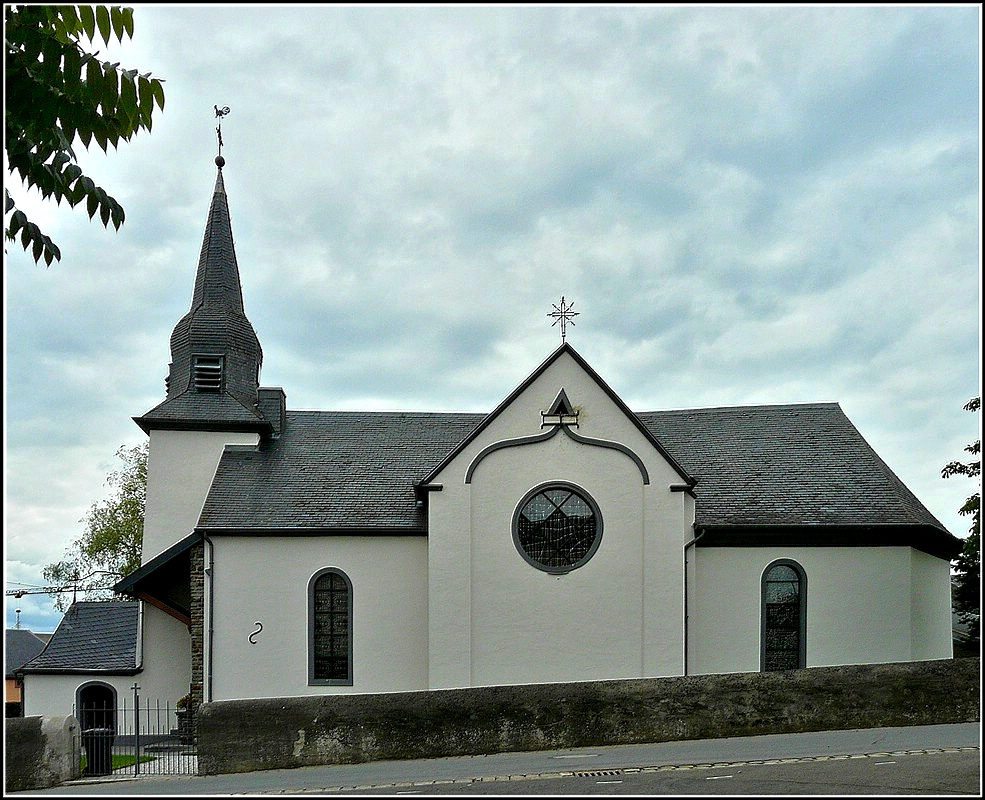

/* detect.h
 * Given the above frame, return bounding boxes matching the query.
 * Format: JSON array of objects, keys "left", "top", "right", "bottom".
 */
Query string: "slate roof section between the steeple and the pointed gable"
[{"left": 199, "top": 411, "right": 485, "bottom": 533}]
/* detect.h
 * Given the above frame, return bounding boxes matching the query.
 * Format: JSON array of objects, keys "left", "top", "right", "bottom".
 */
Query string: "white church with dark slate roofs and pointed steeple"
[{"left": 17, "top": 150, "right": 962, "bottom": 713}]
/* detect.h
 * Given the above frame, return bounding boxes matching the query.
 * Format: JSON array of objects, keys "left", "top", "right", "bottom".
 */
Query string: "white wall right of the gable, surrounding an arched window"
[{"left": 688, "top": 547, "right": 951, "bottom": 674}]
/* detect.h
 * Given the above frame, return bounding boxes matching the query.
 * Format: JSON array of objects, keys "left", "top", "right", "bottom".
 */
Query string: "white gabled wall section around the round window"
[{"left": 429, "top": 355, "right": 693, "bottom": 688}]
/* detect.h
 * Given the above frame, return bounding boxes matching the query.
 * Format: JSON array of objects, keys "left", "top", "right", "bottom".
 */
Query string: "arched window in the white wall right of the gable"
[{"left": 760, "top": 559, "right": 807, "bottom": 672}]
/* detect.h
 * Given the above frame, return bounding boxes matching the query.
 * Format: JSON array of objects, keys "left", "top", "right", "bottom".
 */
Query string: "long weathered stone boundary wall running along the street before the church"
[{"left": 197, "top": 658, "right": 980, "bottom": 775}]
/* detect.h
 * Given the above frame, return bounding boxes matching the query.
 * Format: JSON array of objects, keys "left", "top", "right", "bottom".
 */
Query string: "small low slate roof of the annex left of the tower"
[{"left": 19, "top": 601, "right": 140, "bottom": 675}]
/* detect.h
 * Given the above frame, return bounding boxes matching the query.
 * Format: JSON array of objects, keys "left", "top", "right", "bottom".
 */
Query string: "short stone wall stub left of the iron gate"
[{"left": 3, "top": 717, "right": 81, "bottom": 794}]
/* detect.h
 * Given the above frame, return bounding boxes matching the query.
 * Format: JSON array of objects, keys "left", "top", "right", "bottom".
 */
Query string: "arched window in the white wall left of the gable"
[{"left": 308, "top": 568, "right": 352, "bottom": 686}]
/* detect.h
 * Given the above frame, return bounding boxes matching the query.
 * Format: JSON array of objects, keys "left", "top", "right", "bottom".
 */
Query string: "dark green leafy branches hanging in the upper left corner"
[{"left": 4, "top": 5, "right": 164, "bottom": 266}]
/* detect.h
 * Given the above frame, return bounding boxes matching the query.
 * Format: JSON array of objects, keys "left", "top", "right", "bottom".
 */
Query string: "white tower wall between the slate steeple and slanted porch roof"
[{"left": 141, "top": 430, "right": 259, "bottom": 564}]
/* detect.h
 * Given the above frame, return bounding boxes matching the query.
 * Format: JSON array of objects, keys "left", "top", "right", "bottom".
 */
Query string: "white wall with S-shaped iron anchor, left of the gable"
[{"left": 205, "top": 536, "right": 428, "bottom": 700}]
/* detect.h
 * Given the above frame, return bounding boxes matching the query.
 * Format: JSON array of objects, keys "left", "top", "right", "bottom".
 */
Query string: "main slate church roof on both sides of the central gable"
[{"left": 198, "top": 403, "right": 958, "bottom": 543}]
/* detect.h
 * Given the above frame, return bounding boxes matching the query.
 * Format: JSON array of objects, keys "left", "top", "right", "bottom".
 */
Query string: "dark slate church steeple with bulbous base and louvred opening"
[{"left": 136, "top": 156, "right": 269, "bottom": 430}]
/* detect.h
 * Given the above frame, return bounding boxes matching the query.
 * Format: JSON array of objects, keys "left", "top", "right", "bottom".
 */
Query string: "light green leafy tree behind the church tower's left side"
[{"left": 42, "top": 442, "right": 147, "bottom": 611}]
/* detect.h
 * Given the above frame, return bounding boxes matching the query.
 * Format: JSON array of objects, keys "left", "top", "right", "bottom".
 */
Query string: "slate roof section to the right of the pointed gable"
[{"left": 638, "top": 403, "right": 943, "bottom": 528}]
